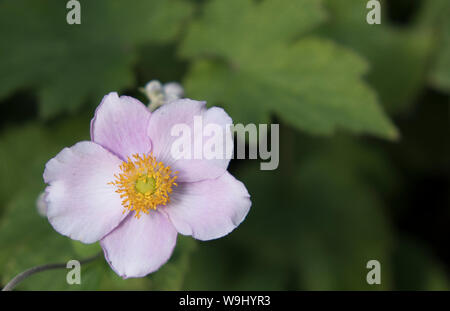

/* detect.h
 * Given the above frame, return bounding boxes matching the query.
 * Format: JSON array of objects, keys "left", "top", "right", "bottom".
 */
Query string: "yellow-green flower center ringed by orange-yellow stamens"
[{"left": 109, "top": 154, "right": 177, "bottom": 218}]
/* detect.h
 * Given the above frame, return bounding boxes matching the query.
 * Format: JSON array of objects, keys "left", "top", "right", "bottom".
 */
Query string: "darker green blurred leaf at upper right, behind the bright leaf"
[{"left": 319, "top": 0, "right": 432, "bottom": 113}]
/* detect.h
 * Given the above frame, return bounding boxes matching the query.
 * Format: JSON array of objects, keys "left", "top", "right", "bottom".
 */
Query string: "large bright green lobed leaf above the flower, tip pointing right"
[{"left": 181, "top": 0, "right": 397, "bottom": 139}]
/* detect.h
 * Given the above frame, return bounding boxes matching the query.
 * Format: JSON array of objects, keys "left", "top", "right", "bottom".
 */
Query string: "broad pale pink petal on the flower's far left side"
[{"left": 44, "top": 141, "right": 126, "bottom": 243}]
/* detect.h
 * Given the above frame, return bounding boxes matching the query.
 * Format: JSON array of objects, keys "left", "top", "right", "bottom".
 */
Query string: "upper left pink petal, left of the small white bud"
[{"left": 91, "top": 92, "right": 152, "bottom": 160}]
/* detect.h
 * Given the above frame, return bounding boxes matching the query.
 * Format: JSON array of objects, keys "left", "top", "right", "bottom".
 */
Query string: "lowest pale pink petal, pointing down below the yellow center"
[{"left": 100, "top": 211, "right": 177, "bottom": 278}]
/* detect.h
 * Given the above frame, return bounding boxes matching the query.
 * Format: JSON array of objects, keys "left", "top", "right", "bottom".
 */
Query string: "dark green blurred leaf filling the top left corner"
[{"left": 0, "top": 0, "right": 192, "bottom": 118}]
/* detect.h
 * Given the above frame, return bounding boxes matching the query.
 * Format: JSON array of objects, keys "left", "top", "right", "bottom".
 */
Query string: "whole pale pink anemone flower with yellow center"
[{"left": 44, "top": 93, "right": 251, "bottom": 278}]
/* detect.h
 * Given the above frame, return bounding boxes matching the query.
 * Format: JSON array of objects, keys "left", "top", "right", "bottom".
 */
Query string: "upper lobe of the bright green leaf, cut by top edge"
[{"left": 182, "top": 0, "right": 324, "bottom": 61}]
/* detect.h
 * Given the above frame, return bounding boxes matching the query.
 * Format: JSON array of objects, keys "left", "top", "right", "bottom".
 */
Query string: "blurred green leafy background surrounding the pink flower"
[{"left": 0, "top": 0, "right": 450, "bottom": 290}]
